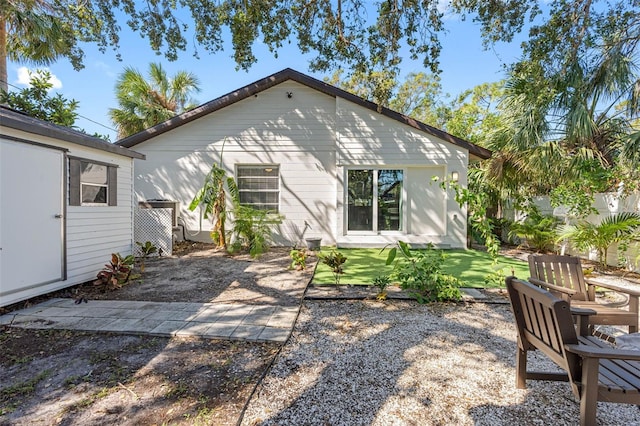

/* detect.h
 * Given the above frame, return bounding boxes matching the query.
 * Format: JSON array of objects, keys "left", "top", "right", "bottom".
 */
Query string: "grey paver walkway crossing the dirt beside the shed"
[{"left": 0, "top": 299, "right": 299, "bottom": 342}]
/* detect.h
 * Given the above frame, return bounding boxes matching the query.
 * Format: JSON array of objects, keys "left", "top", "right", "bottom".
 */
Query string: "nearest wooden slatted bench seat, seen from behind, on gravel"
[{"left": 506, "top": 277, "right": 640, "bottom": 425}]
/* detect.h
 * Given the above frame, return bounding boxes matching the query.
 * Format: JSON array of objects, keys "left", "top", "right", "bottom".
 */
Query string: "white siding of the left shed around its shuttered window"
[{"left": 2, "top": 128, "right": 134, "bottom": 306}]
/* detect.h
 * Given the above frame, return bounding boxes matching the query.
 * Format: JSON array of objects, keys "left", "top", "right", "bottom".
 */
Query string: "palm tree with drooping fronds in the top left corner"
[{"left": 0, "top": 0, "right": 87, "bottom": 92}]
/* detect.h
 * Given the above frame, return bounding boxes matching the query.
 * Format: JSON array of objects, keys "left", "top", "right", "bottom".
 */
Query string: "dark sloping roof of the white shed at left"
[{"left": 0, "top": 105, "right": 145, "bottom": 160}]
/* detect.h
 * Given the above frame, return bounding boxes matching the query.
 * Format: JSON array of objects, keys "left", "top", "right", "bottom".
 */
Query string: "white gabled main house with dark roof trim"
[{"left": 117, "top": 69, "right": 491, "bottom": 248}]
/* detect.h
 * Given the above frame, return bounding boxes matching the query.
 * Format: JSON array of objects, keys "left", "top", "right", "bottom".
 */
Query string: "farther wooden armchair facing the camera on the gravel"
[{"left": 529, "top": 254, "right": 640, "bottom": 333}]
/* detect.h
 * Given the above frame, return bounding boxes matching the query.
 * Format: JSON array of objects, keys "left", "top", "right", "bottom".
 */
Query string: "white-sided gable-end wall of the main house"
[{"left": 134, "top": 81, "right": 468, "bottom": 247}]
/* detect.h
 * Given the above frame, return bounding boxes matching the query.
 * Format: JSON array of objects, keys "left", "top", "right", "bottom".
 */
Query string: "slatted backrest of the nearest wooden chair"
[{"left": 506, "top": 277, "right": 580, "bottom": 383}]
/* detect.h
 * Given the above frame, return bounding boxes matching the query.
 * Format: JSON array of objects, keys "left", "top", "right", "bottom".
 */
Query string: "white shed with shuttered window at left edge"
[{"left": 0, "top": 106, "right": 144, "bottom": 306}]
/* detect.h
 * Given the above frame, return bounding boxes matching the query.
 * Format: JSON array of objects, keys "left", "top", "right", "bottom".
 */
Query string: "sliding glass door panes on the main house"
[{"left": 347, "top": 169, "right": 404, "bottom": 232}]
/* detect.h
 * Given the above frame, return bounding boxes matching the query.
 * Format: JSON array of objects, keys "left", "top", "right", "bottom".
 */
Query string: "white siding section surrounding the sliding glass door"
[{"left": 336, "top": 98, "right": 469, "bottom": 248}]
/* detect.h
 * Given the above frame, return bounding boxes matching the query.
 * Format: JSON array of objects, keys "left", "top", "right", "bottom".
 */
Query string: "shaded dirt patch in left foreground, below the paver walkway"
[{"left": 0, "top": 329, "right": 278, "bottom": 425}]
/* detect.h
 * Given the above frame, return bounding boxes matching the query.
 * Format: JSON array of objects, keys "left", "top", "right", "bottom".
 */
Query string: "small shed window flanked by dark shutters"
[{"left": 69, "top": 158, "right": 118, "bottom": 206}]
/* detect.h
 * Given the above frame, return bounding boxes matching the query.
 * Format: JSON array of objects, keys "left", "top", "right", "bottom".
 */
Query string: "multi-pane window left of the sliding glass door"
[{"left": 236, "top": 165, "right": 280, "bottom": 213}]
